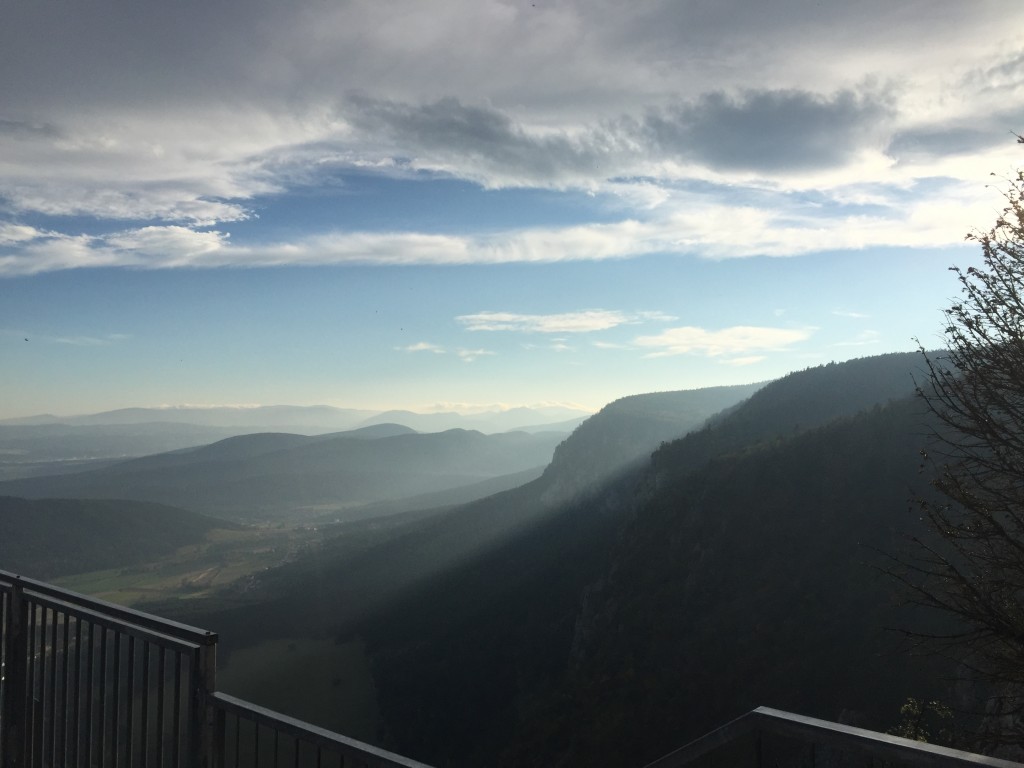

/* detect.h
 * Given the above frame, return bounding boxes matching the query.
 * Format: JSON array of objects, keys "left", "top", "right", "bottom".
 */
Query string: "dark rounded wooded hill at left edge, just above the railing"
[{"left": 0, "top": 496, "right": 233, "bottom": 579}]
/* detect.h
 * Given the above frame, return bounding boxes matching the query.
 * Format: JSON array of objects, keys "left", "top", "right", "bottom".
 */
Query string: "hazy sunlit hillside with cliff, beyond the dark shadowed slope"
[{"left": 162, "top": 387, "right": 756, "bottom": 644}]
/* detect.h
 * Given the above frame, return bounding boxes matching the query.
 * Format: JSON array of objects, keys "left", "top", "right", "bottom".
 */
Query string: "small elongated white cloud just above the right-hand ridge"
[{"left": 633, "top": 326, "right": 813, "bottom": 359}]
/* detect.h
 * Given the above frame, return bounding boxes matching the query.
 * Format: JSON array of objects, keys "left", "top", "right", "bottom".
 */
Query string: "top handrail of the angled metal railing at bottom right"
[{"left": 646, "top": 707, "right": 1021, "bottom": 768}]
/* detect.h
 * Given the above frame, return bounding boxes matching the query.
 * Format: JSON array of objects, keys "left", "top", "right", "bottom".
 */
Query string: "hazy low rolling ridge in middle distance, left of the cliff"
[{"left": 0, "top": 425, "right": 564, "bottom": 517}]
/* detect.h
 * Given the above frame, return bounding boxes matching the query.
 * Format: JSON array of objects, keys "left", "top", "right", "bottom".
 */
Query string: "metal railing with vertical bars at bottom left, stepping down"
[{"left": 0, "top": 570, "right": 427, "bottom": 768}]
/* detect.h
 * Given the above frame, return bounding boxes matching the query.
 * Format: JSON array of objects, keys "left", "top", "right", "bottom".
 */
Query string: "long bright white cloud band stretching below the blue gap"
[{"left": 0, "top": 169, "right": 994, "bottom": 278}]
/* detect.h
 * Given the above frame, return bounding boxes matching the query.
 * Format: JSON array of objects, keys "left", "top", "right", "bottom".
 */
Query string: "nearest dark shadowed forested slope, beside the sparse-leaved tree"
[{"left": 498, "top": 399, "right": 948, "bottom": 766}]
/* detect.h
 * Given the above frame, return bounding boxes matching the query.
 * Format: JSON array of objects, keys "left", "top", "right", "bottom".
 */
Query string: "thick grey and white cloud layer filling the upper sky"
[{"left": 0, "top": 0, "right": 1024, "bottom": 275}]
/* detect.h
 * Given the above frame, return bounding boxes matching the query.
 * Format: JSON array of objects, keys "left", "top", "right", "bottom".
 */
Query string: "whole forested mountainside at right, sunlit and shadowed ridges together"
[{"left": 144, "top": 354, "right": 944, "bottom": 766}]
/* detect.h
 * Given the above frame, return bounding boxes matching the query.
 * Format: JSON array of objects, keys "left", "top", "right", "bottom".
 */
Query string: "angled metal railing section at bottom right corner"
[{"left": 646, "top": 707, "right": 1021, "bottom": 768}]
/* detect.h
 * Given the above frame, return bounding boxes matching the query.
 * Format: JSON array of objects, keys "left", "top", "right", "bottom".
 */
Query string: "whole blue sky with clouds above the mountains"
[{"left": 0, "top": 0, "right": 1024, "bottom": 419}]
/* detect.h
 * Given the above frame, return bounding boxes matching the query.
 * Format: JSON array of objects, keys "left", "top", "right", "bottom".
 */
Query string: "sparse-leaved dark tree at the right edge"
[{"left": 901, "top": 139, "right": 1024, "bottom": 740}]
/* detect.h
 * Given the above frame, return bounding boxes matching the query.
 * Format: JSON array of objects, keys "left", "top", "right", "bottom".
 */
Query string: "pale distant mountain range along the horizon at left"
[{"left": 0, "top": 406, "right": 589, "bottom": 480}]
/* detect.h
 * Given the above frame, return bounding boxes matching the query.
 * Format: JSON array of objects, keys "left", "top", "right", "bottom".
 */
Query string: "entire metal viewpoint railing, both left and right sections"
[{"left": 0, "top": 570, "right": 1021, "bottom": 768}]
